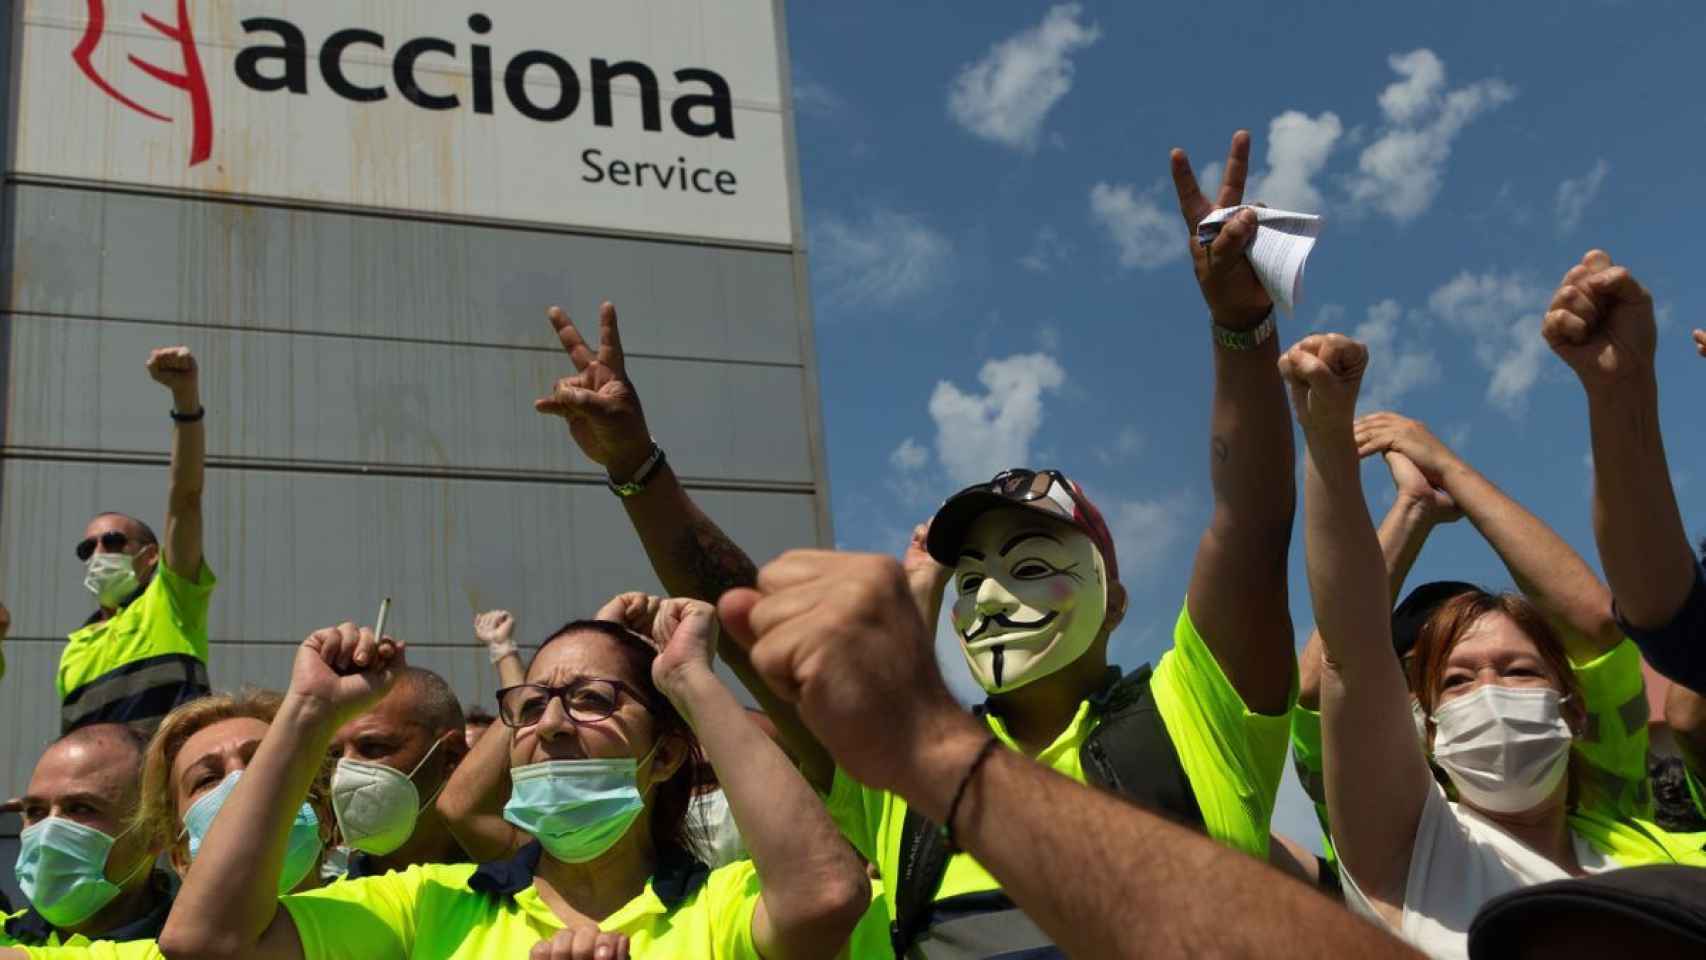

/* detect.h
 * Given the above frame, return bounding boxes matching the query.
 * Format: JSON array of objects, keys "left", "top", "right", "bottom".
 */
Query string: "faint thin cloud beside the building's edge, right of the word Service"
[{"left": 812, "top": 208, "right": 954, "bottom": 307}]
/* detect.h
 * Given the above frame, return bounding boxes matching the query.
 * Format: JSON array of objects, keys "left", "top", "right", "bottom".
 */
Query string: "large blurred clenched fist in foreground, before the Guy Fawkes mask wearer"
[{"left": 717, "top": 551, "right": 966, "bottom": 795}]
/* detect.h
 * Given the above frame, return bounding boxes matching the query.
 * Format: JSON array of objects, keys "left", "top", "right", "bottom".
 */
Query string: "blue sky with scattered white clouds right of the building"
[{"left": 790, "top": 0, "right": 1706, "bottom": 842}]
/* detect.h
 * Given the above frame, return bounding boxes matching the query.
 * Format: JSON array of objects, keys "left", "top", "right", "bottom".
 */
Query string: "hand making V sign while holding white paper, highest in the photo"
[{"left": 1170, "top": 130, "right": 1274, "bottom": 329}]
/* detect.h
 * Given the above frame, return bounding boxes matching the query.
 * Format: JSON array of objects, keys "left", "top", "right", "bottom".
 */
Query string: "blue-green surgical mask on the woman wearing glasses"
[{"left": 503, "top": 745, "right": 657, "bottom": 863}]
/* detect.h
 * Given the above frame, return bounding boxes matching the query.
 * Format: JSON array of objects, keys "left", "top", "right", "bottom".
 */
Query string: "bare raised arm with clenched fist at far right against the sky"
[{"left": 1542, "top": 251, "right": 1696, "bottom": 634}]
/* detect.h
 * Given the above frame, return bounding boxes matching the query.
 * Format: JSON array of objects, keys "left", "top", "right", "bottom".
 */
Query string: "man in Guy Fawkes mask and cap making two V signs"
[{"left": 534, "top": 131, "right": 1297, "bottom": 958}]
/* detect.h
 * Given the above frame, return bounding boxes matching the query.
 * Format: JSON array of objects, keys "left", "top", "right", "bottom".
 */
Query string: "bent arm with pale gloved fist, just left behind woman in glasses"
[{"left": 433, "top": 610, "right": 527, "bottom": 863}]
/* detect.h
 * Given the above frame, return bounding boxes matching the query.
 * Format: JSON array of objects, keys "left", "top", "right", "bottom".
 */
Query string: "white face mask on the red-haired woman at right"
[{"left": 1433, "top": 684, "right": 1575, "bottom": 813}]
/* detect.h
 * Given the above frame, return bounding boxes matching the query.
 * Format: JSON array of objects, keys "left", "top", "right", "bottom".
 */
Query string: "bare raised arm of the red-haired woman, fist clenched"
[{"left": 1280, "top": 334, "right": 1433, "bottom": 909}]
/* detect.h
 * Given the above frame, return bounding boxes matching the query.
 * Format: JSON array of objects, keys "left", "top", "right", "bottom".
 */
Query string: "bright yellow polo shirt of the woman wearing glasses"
[{"left": 280, "top": 859, "right": 761, "bottom": 960}]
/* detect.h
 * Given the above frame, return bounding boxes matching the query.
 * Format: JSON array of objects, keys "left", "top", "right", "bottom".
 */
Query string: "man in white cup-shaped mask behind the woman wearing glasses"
[{"left": 331, "top": 667, "right": 467, "bottom": 880}]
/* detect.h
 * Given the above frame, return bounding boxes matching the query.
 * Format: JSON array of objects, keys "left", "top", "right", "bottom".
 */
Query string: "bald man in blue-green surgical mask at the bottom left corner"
[{"left": 0, "top": 723, "right": 172, "bottom": 946}]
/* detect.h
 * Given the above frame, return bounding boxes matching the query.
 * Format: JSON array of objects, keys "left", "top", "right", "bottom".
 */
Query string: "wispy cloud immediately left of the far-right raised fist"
[{"left": 1428, "top": 271, "right": 1547, "bottom": 416}]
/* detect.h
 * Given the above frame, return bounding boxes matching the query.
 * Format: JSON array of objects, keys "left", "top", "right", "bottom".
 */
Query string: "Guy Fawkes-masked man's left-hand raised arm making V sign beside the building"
[{"left": 534, "top": 304, "right": 834, "bottom": 791}]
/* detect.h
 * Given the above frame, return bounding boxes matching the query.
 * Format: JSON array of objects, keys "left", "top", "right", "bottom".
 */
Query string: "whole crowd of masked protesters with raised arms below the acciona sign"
[{"left": 0, "top": 131, "right": 1706, "bottom": 960}]
